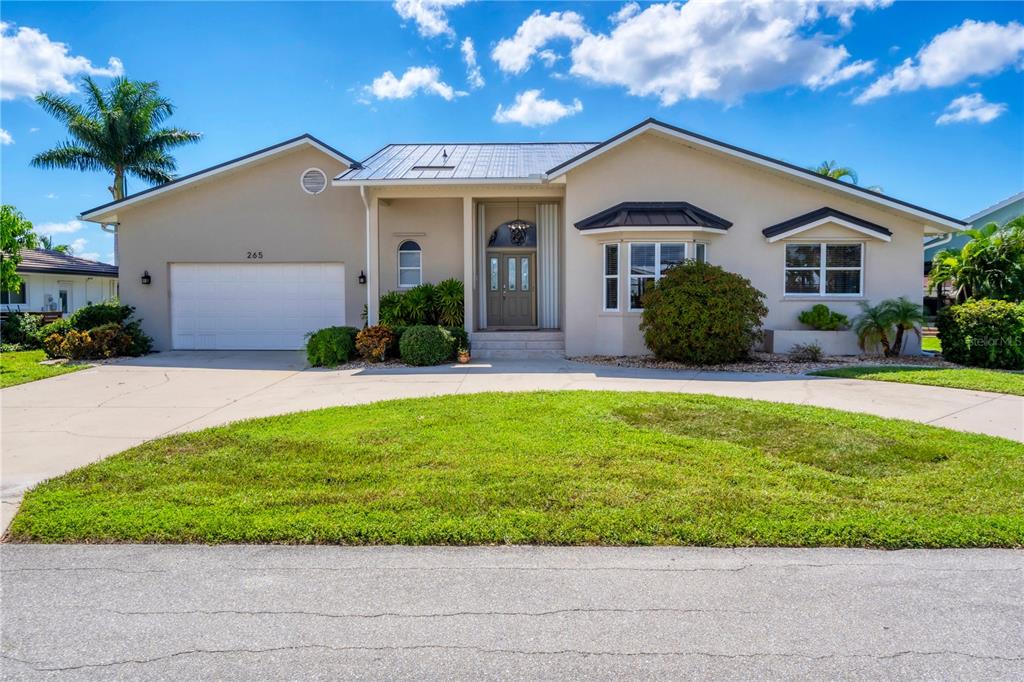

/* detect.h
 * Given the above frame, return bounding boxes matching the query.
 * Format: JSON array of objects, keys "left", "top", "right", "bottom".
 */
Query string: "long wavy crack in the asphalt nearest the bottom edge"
[{"left": 0, "top": 644, "right": 1024, "bottom": 673}]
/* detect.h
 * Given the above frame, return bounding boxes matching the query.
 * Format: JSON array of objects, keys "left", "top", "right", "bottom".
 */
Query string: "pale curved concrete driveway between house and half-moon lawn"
[{"left": 0, "top": 351, "right": 1024, "bottom": 528}]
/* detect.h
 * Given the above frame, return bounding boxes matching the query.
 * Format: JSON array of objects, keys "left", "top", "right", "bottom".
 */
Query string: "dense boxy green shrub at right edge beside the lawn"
[{"left": 937, "top": 299, "right": 1024, "bottom": 370}]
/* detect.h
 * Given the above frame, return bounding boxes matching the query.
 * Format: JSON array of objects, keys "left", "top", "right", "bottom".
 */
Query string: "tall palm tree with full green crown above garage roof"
[{"left": 32, "top": 76, "right": 201, "bottom": 201}]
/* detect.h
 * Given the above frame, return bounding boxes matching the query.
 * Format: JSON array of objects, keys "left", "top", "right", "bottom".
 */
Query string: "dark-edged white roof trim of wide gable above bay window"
[{"left": 547, "top": 118, "right": 966, "bottom": 230}]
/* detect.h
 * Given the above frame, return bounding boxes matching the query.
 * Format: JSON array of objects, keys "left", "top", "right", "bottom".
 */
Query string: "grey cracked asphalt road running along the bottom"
[{"left": 0, "top": 545, "right": 1024, "bottom": 680}]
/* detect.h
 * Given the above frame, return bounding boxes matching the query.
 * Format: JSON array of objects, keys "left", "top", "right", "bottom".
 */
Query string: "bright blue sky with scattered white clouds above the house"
[{"left": 0, "top": 0, "right": 1024, "bottom": 260}]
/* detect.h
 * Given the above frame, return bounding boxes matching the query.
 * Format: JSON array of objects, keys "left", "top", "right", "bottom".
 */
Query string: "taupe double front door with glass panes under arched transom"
[{"left": 487, "top": 251, "right": 537, "bottom": 327}]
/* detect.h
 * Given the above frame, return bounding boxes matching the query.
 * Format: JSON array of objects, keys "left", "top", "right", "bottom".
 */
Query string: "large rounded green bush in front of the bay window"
[{"left": 640, "top": 261, "right": 768, "bottom": 365}]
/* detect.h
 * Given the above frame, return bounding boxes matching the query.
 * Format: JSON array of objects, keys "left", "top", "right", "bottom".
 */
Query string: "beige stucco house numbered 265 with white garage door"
[{"left": 82, "top": 119, "right": 964, "bottom": 357}]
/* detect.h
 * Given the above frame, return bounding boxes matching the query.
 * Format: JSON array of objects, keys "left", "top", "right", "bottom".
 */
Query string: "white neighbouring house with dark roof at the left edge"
[{"left": 0, "top": 249, "right": 118, "bottom": 315}]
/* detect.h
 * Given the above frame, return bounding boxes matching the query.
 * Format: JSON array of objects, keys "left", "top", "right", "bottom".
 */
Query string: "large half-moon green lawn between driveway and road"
[{"left": 10, "top": 391, "right": 1024, "bottom": 548}]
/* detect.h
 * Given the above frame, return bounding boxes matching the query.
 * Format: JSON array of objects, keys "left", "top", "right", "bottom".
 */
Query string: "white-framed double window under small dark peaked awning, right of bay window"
[{"left": 785, "top": 244, "right": 864, "bottom": 296}]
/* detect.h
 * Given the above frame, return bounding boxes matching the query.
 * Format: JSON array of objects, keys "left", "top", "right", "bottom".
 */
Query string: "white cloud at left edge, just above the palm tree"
[{"left": 0, "top": 22, "right": 124, "bottom": 99}]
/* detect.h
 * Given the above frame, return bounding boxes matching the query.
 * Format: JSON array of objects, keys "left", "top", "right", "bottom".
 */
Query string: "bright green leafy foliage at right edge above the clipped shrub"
[{"left": 928, "top": 216, "right": 1024, "bottom": 301}]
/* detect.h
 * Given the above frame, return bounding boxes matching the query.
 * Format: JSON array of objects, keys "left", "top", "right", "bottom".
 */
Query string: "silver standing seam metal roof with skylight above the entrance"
[{"left": 335, "top": 142, "right": 597, "bottom": 182}]
